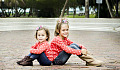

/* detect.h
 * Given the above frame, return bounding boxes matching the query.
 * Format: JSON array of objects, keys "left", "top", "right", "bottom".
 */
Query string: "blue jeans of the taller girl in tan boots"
[{"left": 53, "top": 43, "right": 82, "bottom": 65}]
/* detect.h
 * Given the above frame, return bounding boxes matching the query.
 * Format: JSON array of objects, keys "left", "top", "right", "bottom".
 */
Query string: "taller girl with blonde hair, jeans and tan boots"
[{"left": 48, "top": 19, "right": 102, "bottom": 66}]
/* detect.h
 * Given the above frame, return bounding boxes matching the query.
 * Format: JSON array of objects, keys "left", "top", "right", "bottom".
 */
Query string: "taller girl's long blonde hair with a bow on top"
[{"left": 54, "top": 18, "right": 69, "bottom": 36}]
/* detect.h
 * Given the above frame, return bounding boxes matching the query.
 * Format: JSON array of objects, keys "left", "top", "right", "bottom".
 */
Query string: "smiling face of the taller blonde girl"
[{"left": 59, "top": 24, "right": 69, "bottom": 39}]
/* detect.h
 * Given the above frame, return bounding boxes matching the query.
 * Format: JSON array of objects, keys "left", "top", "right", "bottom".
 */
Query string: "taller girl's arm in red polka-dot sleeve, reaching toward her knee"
[{"left": 52, "top": 38, "right": 81, "bottom": 55}]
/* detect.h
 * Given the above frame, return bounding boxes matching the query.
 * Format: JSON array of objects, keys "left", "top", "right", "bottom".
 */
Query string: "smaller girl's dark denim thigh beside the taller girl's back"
[{"left": 37, "top": 52, "right": 52, "bottom": 66}]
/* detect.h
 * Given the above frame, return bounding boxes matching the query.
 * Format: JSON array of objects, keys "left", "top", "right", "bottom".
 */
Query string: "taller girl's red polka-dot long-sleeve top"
[{"left": 46, "top": 36, "right": 86, "bottom": 61}]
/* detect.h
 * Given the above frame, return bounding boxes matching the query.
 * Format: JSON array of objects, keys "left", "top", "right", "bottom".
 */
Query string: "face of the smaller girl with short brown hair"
[{"left": 37, "top": 30, "right": 48, "bottom": 43}]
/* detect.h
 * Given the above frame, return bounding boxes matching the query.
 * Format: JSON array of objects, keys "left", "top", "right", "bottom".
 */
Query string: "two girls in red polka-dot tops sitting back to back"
[{"left": 17, "top": 19, "right": 103, "bottom": 66}]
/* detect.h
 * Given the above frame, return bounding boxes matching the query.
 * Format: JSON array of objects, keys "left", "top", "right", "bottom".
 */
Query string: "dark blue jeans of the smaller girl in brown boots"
[{"left": 28, "top": 52, "right": 52, "bottom": 66}]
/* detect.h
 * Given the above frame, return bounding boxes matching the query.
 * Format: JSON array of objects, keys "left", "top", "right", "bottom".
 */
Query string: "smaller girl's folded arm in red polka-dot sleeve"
[{"left": 30, "top": 42, "right": 50, "bottom": 54}]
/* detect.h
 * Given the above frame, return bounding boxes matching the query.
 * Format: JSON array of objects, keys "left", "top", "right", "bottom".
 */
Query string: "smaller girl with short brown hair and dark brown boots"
[{"left": 17, "top": 26, "right": 51, "bottom": 66}]
